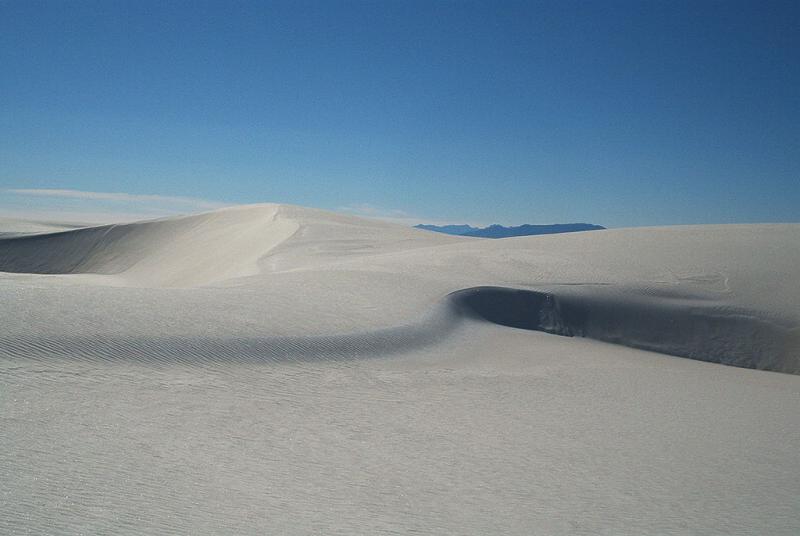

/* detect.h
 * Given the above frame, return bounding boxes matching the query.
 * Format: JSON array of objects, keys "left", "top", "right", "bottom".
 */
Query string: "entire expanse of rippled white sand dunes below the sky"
[{"left": 0, "top": 205, "right": 800, "bottom": 535}]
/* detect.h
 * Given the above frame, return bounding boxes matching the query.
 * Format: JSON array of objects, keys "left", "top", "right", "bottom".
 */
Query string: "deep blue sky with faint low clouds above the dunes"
[{"left": 0, "top": 0, "right": 800, "bottom": 227}]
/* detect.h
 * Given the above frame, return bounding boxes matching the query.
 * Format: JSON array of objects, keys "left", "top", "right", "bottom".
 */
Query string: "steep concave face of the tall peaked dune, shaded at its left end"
[{"left": 0, "top": 205, "right": 298, "bottom": 286}]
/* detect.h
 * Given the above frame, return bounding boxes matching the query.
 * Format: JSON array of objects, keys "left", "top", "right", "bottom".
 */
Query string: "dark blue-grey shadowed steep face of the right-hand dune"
[{"left": 450, "top": 287, "right": 800, "bottom": 374}]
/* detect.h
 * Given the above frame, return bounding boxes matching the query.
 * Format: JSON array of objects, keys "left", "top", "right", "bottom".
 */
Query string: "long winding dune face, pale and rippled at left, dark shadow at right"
[{"left": 0, "top": 286, "right": 800, "bottom": 374}]
